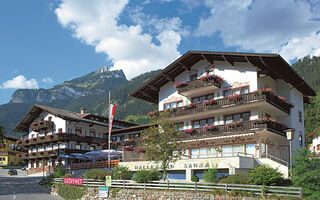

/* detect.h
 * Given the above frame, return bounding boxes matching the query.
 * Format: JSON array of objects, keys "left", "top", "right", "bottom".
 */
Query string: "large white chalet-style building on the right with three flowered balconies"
[{"left": 116, "top": 51, "right": 315, "bottom": 181}]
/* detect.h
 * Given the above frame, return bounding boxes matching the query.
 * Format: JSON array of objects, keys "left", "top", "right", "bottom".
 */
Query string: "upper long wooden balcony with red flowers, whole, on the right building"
[{"left": 162, "top": 92, "right": 292, "bottom": 119}]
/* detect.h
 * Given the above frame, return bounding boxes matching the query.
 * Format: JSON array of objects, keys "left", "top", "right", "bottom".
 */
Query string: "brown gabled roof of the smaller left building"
[{"left": 13, "top": 104, "right": 129, "bottom": 132}]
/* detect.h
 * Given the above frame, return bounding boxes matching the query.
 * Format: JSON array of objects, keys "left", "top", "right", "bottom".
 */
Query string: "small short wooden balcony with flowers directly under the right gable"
[{"left": 177, "top": 78, "right": 221, "bottom": 96}]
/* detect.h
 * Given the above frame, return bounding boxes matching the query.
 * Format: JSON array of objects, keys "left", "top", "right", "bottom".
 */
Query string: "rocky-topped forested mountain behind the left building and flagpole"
[{"left": 0, "top": 67, "right": 159, "bottom": 133}]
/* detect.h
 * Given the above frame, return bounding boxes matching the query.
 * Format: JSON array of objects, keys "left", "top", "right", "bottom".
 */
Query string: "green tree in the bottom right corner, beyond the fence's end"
[{"left": 292, "top": 147, "right": 320, "bottom": 199}]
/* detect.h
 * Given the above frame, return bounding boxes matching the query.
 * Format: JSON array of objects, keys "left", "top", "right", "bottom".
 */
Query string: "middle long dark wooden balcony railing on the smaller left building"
[{"left": 17, "top": 133, "right": 106, "bottom": 146}]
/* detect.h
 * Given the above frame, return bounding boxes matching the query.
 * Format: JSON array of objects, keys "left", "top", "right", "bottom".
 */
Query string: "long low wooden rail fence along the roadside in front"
[{"left": 53, "top": 178, "right": 303, "bottom": 199}]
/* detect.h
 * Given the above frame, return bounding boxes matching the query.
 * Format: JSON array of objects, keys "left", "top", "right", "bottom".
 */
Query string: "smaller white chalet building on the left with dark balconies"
[{"left": 14, "top": 105, "right": 135, "bottom": 174}]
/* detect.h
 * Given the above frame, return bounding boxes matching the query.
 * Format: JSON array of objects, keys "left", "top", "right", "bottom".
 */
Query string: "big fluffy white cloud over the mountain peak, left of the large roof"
[{"left": 55, "top": 0, "right": 183, "bottom": 79}]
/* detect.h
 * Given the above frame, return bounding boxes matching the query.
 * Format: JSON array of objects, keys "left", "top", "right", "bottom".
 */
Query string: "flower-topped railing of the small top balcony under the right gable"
[{"left": 177, "top": 78, "right": 221, "bottom": 94}]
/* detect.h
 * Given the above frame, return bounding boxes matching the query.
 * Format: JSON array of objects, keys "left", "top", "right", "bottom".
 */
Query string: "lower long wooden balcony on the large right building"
[{"left": 181, "top": 119, "right": 287, "bottom": 140}]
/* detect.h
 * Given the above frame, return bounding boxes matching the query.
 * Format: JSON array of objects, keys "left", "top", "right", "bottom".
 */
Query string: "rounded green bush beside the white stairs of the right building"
[{"left": 248, "top": 165, "right": 284, "bottom": 185}]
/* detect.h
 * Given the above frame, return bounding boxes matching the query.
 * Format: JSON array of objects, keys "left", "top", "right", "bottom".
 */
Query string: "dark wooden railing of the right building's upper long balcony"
[{"left": 160, "top": 92, "right": 292, "bottom": 117}]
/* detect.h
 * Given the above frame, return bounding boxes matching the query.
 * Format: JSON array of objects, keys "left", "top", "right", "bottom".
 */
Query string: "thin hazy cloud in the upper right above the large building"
[{"left": 195, "top": 0, "right": 320, "bottom": 60}]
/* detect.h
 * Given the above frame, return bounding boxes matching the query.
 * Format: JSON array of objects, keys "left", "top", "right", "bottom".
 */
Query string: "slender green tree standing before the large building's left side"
[{"left": 141, "top": 112, "right": 185, "bottom": 180}]
